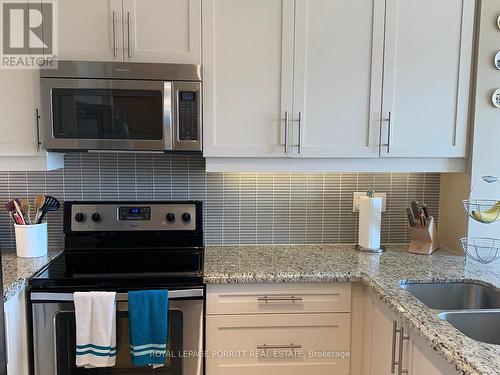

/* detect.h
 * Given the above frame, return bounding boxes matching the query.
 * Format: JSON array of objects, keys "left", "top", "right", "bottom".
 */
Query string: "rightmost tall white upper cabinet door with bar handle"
[{"left": 381, "top": 0, "right": 475, "bottom": 158}]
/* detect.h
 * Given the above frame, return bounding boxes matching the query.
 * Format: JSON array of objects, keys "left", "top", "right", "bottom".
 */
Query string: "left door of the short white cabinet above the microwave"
[{"left": 57, "top": 0, "right": 123, "bottom": 61}]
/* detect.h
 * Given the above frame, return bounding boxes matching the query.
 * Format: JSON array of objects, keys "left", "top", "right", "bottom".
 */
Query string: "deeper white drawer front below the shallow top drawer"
[{"left": 206, "top": 313, "right": 350, "bottom": 375}]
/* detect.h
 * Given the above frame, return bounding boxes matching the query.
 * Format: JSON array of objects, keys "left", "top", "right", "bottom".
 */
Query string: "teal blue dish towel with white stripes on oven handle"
[{"left": 128, "top": 290, "right": 168, "bottom": 368}]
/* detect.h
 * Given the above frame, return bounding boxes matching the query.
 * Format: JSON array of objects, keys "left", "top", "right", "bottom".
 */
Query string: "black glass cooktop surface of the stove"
[{"left": 30, "top": 249, "right": 203, "bottom": 291}]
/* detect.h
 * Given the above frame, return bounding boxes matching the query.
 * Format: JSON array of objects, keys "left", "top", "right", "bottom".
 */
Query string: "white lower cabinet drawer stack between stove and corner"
[{"left": 206, "top": 283, "right": 351, "bottom": 375}]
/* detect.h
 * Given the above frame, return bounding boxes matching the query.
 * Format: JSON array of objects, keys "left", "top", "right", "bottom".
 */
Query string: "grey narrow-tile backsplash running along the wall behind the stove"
[{"left": 0, "top": 153, "right": 440, "bottom": 249}]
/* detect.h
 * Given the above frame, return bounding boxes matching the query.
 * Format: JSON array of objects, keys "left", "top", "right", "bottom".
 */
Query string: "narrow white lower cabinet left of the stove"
[{"left": 4, "top": 290, "right": 28, "bottom": 375}]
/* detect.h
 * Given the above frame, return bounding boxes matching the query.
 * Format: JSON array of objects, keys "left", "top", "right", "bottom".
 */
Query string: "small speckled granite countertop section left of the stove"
[{"left": 2, "top": 250, "right": 61, "bottom": 301}]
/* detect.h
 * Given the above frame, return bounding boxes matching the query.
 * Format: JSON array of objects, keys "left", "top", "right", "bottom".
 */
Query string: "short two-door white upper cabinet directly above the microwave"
[{"left": 58, "top": 0, "right": 201, "bottom": 64}]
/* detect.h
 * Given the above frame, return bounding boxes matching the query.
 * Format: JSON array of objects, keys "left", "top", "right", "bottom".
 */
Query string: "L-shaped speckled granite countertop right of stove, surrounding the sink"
[{"left": 205, "top": 245, "right": 500, "bottom": 375}]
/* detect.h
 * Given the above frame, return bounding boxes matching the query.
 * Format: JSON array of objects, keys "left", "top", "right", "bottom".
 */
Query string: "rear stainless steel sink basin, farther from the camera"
[{"left": 401, "top": 282, "right": 500, "bottom": 310}]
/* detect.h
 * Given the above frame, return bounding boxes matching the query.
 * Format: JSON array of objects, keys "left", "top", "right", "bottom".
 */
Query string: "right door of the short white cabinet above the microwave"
[{"left": 123, "top": 0, "right": 201, "bottom": 64}]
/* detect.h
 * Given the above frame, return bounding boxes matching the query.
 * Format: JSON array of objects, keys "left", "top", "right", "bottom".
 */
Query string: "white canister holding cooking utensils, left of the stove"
[{"left": 14, "top": 222, "right": 48, "bottom": 258}]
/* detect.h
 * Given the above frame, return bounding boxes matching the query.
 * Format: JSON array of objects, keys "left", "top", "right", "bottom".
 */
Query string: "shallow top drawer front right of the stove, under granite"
[{"left": 207, "top": 283, "right": 351, "bottom": 315}]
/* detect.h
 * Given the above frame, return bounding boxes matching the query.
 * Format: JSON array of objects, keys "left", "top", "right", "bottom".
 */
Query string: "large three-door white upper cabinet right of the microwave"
[{"left": 202, "top": 0, "right": 475, "bottom": 171}]
